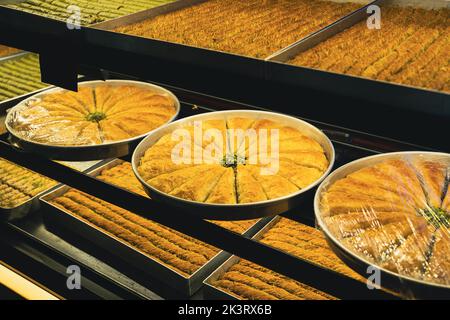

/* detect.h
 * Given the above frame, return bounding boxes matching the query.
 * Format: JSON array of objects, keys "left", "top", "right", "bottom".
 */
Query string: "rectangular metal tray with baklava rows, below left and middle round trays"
[{"left": 41, "top": 159, "right": 268, "bottom": 296}]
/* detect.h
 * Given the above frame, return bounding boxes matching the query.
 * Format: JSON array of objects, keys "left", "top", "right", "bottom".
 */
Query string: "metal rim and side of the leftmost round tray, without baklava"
[{"left": 5, "top": 80, "right": 180, "bottom": 161}]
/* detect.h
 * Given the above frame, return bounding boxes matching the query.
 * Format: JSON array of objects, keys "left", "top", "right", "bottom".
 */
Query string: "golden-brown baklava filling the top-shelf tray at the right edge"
[{"left": 289, "top": 6, "right": 450, "bottom": 92}]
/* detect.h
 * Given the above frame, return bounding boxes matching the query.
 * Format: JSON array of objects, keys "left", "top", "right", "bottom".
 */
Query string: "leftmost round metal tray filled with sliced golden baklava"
[{"left": 5, "top": 80, "right": 180, "bottom": 161}]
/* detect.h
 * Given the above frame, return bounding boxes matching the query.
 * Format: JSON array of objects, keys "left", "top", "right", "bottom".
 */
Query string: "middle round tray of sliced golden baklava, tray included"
[{"left": 132, "top": 110, "right": 334, "bottom": 220}]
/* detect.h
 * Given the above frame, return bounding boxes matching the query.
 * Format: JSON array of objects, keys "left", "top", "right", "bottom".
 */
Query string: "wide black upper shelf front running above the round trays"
[{"left": 0, "top": 0, "right": 450, "bottom": 150}]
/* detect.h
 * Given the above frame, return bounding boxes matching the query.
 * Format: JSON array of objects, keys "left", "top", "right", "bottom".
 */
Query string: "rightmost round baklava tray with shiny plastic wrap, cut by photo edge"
[{"left": 314, "top": 152, "right": 450, "bottom": 298}]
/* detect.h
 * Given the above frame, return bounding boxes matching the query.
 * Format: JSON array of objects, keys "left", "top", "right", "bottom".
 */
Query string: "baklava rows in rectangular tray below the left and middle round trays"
[{"left": 50, "top": 162, "right": 257, "bottom": 277}]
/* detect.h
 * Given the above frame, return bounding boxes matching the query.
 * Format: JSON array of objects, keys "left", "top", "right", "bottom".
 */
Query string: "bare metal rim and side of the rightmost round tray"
[{"left": 314, "top": 151, "right": 450, "bottom": 298}]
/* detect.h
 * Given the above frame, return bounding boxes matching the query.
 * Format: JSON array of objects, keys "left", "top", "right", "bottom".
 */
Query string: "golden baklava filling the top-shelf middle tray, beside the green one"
[{"left": 115, "top": 0, "right": 362, "bottom": 58}]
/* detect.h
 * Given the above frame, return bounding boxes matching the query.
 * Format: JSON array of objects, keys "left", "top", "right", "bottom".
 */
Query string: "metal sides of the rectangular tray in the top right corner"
[{"left": 267, "top": 0, "right": 450, "bottom": 117}]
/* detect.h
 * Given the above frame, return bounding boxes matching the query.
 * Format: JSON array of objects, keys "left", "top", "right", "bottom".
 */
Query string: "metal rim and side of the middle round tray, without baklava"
[{"left": 132, "top": 110, "right": 335, "bottom": 221}]
